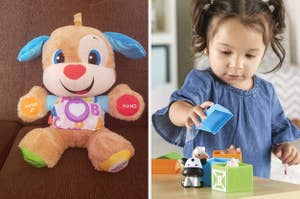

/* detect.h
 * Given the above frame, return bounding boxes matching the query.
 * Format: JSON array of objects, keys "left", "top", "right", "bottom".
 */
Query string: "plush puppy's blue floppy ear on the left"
[{"left": 18, "top": 35, "right": 49, "bottom": 62}]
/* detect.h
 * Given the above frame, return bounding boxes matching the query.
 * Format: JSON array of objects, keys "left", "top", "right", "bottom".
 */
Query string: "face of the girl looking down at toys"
[{"left": 208, "top": 18, "right": 266, "bottom": 90}]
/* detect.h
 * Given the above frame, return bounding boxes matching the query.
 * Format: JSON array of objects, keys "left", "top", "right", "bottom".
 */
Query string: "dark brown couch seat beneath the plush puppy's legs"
[{"left": 0, "top": 127, "right": 148, "bottom": 199}]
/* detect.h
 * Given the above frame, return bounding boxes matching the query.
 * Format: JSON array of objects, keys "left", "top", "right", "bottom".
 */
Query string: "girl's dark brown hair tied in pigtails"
[{"left": 192, "top": 0, "right": 285, "bottom": 72}]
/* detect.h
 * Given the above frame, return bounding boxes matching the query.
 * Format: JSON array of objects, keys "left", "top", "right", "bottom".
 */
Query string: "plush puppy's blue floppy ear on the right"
[{"left": 104, "top": 32, "right": 146, "bottom": 59}]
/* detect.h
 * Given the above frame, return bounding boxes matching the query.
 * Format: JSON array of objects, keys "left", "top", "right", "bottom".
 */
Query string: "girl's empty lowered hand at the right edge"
[{"left": 273, "top": 142, "right": 300, "bottom": 166}]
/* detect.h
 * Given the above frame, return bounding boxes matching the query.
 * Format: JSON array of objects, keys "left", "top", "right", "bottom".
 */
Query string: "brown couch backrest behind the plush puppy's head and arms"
[{"left": 0, "top": 0, "right": 148, "bottom": 125}]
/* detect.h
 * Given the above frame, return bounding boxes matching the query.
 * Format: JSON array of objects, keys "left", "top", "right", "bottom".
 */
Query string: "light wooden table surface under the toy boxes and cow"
[{"left": 152, "top": 175, "right": 300, "bottom": 199}]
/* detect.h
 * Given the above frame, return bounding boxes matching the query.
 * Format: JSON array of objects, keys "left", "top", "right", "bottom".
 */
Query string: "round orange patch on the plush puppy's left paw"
[{"left": 21, "top": 97, "right": 41, "bottom": 116}]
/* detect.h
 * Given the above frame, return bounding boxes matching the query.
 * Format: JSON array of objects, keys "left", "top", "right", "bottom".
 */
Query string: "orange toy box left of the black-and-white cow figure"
[{"left": 152, "top": 159, "right": 181, "bottom": 174}]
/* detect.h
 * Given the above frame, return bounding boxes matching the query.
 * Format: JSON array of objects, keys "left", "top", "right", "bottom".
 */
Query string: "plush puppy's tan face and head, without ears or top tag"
[{"left": 42, "top": 26, "right": 116, "bottom": 96}]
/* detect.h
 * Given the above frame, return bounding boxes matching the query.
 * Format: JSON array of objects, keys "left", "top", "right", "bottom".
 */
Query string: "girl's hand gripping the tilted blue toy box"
[{"left": 185, "top": 101, "right": 214, "bottom": 129}]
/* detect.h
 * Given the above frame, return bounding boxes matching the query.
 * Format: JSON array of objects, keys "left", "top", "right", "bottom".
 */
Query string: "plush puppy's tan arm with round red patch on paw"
[{"left": 108, "top": 84, "right": 145, "bottom": 121}]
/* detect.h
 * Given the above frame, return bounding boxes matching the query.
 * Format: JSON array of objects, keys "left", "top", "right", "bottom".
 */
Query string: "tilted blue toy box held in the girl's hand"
[{"left": 194, "top": 104, "right": 233, "bottom": 135}]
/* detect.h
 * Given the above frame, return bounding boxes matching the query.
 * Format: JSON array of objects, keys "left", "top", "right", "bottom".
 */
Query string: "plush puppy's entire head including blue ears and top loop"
[{"left": 18, "top": 12, "right": 145, "bottom": 97}]
